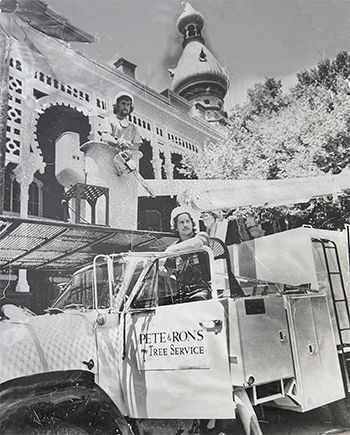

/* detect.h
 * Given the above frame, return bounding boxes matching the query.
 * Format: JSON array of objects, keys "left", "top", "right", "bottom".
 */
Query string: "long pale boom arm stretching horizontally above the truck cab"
[{"left": 139, "top": 169, "right": 350, "bottom": 211}]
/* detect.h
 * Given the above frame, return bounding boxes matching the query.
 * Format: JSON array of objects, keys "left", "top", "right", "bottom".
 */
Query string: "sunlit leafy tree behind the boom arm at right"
[{"left": 187, "top": 52, "right": 350, "bottom": 227}]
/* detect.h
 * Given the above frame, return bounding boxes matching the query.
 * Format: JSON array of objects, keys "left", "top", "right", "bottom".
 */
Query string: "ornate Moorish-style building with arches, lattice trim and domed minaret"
[{"left": 0, "top": 0, "right": 228, "bottom": 314}]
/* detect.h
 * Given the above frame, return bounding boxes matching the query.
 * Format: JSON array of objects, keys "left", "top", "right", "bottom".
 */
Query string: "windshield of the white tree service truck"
[{"left": 52, "top": 258, "right": 124, "bottom": 310}]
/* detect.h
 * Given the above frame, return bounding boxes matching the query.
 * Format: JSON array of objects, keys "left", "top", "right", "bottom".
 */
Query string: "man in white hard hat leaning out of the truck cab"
[{"left": 161, "top": 206, "right": 211, "bottom": 302}]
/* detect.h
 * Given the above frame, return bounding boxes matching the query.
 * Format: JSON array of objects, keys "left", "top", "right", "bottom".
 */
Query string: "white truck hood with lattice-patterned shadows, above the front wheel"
[{"left": 0, "top": 310, "right": 97, "bottom": 384}]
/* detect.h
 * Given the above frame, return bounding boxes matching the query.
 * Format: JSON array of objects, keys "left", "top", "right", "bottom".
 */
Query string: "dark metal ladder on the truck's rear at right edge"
[{"left": 312, "top": 239, "right": 350, "bottom": 396}]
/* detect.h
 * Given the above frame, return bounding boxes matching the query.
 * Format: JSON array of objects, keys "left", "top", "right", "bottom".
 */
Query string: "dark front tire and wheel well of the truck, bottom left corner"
[{"left": 0, "top": 370, "right": 132, "bottom": 435}]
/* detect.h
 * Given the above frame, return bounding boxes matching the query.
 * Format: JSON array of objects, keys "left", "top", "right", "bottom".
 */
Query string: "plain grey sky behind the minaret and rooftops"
[{"left": 45, "top": 0, "right": 350, "bottom": 110}]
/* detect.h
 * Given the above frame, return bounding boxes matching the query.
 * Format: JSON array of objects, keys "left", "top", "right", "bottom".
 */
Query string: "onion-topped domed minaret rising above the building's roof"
[{"left": 171, "top": 3, "right": 229, "bottom": 122}]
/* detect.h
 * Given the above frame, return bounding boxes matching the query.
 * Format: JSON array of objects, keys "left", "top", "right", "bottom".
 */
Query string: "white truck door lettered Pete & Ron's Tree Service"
[{"left": 122, "top": 251, "right": 235, "bottom": 418}]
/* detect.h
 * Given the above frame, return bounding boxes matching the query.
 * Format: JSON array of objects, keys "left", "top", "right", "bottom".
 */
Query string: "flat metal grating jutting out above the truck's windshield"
[{"left": 0, "top": 216, "right": 174, "bottom": 271}]
